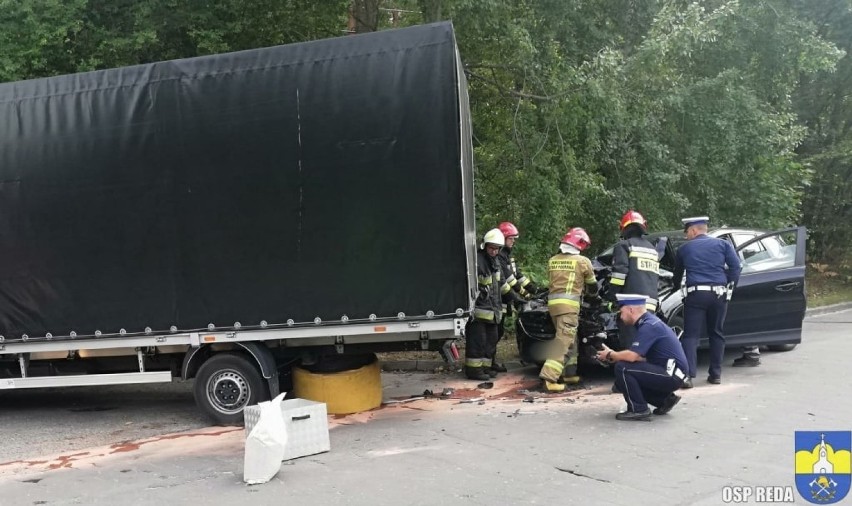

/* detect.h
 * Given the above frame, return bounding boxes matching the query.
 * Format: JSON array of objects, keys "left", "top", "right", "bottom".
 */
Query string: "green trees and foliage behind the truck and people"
[{"left": 0, "top": 0, "right": 852, "bottom": 270}]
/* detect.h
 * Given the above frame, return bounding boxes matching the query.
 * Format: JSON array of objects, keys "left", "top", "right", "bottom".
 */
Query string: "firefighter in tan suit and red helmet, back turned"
[{"left": 539, "top": 227, "right": 598, "bottom": 392}]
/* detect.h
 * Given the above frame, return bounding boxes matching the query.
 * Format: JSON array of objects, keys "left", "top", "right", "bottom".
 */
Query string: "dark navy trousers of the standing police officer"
[{"left": 680, "top": 290, "right": 728, "bottom": 378}]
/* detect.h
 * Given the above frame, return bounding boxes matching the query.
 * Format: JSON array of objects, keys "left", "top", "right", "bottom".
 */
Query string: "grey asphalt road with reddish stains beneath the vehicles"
[{"left": 0, "top": 311, "right": 852, "bottom": 506}]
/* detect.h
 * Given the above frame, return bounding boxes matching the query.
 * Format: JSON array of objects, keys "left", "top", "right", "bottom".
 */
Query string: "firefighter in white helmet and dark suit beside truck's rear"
[{"left": 464, "top": 228, "right": 505, "bottom": 381}]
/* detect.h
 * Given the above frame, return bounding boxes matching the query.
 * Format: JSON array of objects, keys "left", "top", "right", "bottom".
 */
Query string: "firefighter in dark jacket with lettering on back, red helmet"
[{"left": 607, "top": 209, "right": 660, "bottom": 349}]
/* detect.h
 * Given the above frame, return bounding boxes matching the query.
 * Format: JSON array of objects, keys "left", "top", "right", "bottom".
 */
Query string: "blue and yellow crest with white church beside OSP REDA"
[{"left": 796, "top": 431, "right": 852, "bottom": 504}]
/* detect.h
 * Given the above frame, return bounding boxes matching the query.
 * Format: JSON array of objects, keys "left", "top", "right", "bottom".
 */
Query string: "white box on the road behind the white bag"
[{"left": 243, "top": 399, "right": 331, "bottom": 460}]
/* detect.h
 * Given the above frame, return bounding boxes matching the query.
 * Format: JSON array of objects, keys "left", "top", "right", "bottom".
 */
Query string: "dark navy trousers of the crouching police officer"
[{"left": 615, "top": 361, "right": 683, "bottom": 413}]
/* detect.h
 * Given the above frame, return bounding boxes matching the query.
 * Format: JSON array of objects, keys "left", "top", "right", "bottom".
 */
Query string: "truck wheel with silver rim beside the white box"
[{"left": 194, "top": 353, "right": 269, "bottom": 425}]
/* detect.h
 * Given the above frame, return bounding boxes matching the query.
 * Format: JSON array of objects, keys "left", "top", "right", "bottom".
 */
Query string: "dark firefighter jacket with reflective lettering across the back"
[{"left": 607, "top": 237, "right": 660, "bottom": 311}]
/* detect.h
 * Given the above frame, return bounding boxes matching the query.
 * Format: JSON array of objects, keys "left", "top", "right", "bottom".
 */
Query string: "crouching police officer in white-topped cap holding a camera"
[{"left": 597, "top": 294, "right": 687, "bottom": 420}]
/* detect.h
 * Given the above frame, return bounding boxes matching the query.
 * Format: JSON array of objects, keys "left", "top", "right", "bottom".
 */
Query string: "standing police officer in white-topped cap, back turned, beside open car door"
[{"left": 672, "top": 216, "right": 742, "bottom": 388}]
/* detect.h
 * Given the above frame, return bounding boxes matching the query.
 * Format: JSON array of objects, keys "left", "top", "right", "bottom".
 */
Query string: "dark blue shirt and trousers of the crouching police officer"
[{"left": 615, "top": 313, "right": 686, "bottom": 414}]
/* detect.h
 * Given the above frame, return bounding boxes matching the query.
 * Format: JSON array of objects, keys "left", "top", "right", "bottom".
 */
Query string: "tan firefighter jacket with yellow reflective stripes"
[{"left": 547, "top": 253, "right": 598, "bottom": 316}]
